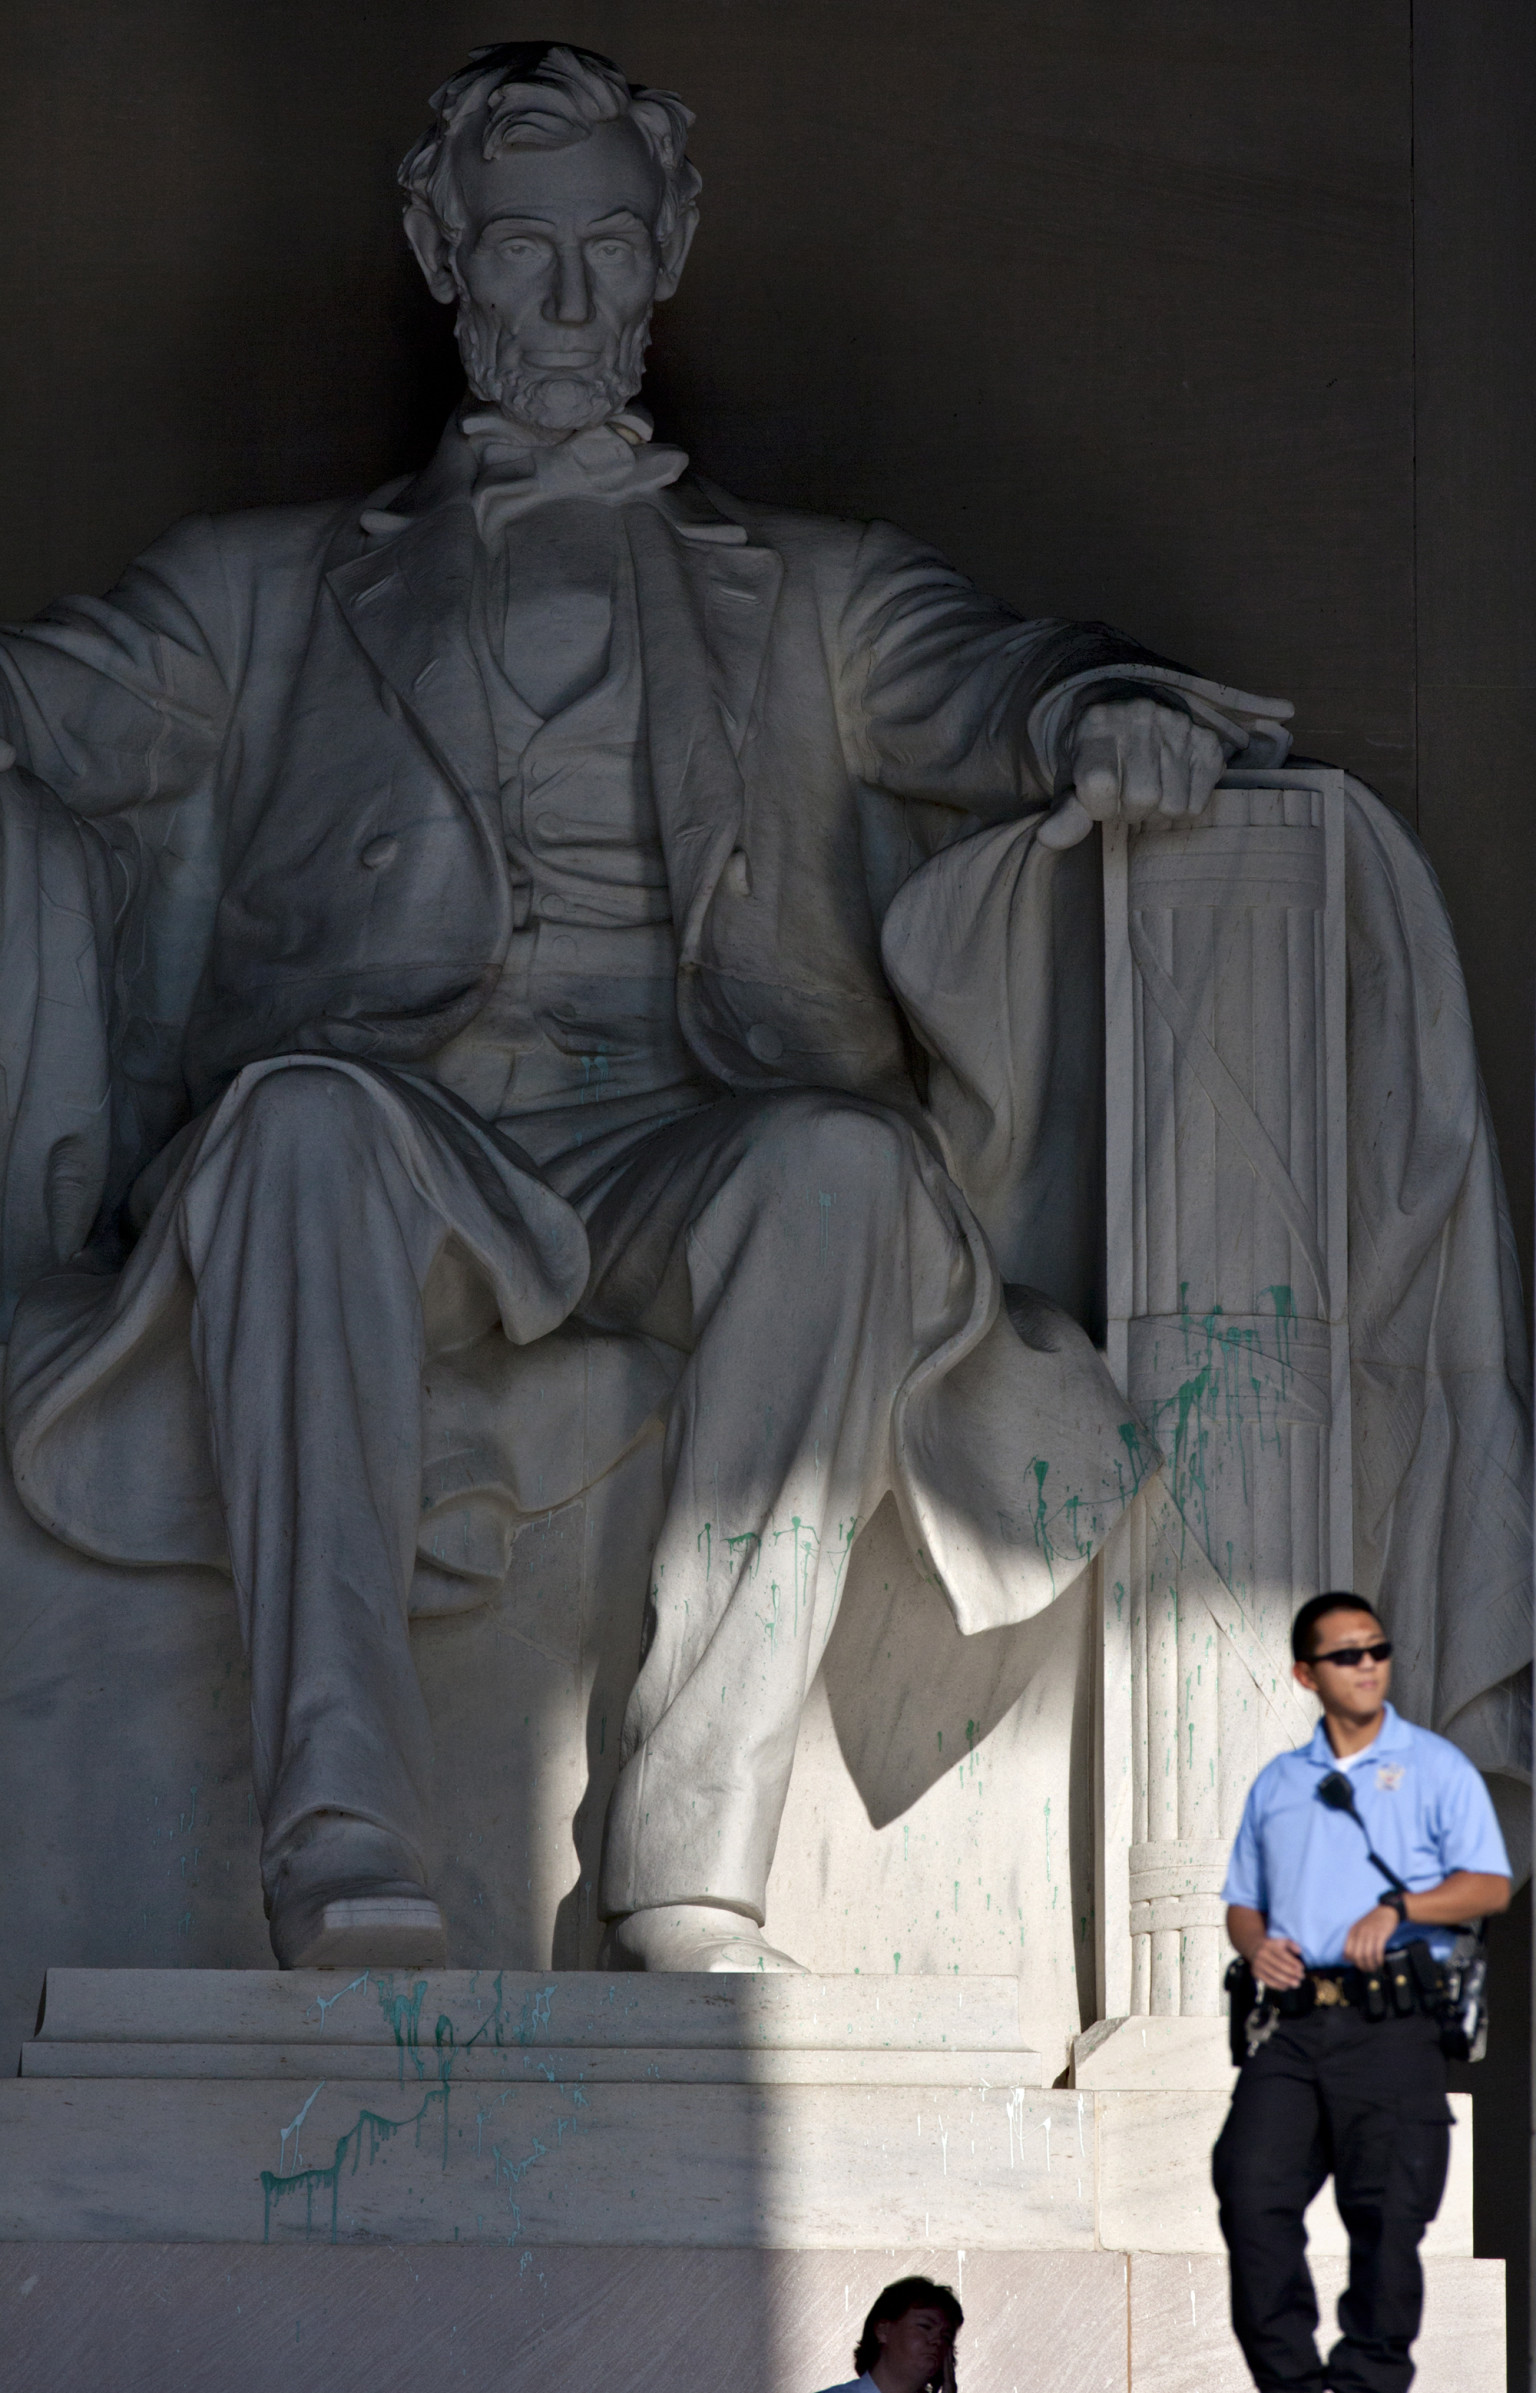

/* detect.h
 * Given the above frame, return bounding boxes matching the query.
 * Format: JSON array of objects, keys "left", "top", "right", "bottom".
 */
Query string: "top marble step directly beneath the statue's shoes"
[{"left": 36, "top": 1969, "right": 1038, "bottom": 2080}]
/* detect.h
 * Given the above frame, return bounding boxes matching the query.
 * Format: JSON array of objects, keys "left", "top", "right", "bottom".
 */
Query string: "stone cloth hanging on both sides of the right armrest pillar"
[{"left": 883, "top": 780, "right": 1531, "bottom": 1837}]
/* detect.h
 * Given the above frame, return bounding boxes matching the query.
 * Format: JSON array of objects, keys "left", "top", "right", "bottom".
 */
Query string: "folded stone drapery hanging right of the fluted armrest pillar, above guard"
[{"left": 1347, "top": 783, "right": 1531, "bottom": 1828}]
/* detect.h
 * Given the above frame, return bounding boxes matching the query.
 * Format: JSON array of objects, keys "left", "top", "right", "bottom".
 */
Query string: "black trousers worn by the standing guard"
[{"left": 1213, "top": 2008, "right": 1450, "bottom": 2393}]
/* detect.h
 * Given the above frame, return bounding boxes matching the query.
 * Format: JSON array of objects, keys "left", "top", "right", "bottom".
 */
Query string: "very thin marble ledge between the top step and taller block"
[{"left": 22, "top": 2039, "right": 1043, "bottom": 2089}]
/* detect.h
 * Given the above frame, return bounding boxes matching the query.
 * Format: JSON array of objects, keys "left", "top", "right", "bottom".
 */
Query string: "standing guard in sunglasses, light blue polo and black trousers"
[{"left": 1213, "top": 1594, "right": 1510, "bottom": 2393}]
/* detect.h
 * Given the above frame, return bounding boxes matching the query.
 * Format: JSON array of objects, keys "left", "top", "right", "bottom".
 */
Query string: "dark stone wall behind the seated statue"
[{"left": 0, "top": 0, "right": 1536, "bottom": 2383}]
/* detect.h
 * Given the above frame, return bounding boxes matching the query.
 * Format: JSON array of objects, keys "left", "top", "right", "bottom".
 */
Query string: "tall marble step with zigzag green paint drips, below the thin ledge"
[{"left": 0, "top": 2070, "right": 1093, "bottom": 2252}]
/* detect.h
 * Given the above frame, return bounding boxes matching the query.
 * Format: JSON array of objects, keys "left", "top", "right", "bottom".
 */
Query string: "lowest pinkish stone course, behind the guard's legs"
[{"left": 0, "top": 2242, "right": 1505, "bottom": 2393}]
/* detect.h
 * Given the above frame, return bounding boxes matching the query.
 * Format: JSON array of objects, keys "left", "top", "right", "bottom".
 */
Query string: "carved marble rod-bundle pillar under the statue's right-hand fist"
[{"left": 1103, "top": 771, "right": 1352, "bottom": 2015}]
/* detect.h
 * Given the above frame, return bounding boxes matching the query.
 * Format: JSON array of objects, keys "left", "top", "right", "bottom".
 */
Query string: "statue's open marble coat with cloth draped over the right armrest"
[{"left": 0, "top": 431, "right": 1529, "bottom": 1809}]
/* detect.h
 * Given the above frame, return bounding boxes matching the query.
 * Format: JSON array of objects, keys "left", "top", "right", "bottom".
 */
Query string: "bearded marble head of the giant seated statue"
[{"left": 400, "top": 41, "right": 699, "bottom": 440}]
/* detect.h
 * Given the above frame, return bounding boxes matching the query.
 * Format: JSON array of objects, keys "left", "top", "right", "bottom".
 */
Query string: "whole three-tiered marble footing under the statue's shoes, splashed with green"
[{"left": 0, "top": 1969, "right": 1062, "bottom": 2252}]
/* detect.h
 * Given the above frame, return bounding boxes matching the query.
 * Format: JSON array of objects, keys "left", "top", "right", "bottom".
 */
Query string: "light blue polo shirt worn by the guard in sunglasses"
[{"left": 1223, "top": 1704, "right": 1510, "bottom": 1969}]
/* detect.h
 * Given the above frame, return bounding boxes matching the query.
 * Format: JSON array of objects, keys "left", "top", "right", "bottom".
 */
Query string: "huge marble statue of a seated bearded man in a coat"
[{"left": 0, "top": 43, "right": 1529, "bottom": 1969}]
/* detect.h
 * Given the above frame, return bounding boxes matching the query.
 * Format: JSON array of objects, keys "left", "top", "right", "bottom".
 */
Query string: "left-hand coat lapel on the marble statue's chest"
[{"left": 325, "top": 500, "right": 495, "bottom": 806}]
